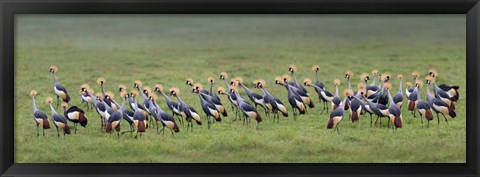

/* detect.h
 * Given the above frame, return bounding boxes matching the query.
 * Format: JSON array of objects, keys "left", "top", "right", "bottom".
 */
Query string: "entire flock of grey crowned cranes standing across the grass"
[{"left": 30, "top": 65, "right": 459, "bottom": 138}]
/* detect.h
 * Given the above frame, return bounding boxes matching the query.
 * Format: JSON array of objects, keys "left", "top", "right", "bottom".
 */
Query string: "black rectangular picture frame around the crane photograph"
[{"left": 0, "top": 0, "right": 480, "bottom": 176}]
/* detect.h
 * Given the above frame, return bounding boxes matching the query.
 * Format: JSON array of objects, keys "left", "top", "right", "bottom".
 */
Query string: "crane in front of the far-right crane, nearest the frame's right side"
[{"left": 425, "top": 76, "right": 457, "bottom": 125}]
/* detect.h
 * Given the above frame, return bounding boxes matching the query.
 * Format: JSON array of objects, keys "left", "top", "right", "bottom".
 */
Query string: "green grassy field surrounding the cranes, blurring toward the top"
[{"left": 14, "top": 15, "right": 466, "bottom": 163}]
